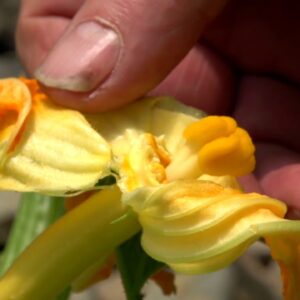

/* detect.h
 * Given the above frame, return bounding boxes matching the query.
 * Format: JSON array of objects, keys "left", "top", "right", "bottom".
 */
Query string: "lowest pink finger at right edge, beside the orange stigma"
[{"left": 256, "top": 143, "right": 300, "bottom": 210}]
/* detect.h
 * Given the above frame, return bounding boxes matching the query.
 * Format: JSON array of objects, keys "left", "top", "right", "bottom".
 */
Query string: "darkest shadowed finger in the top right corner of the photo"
[{"left": 205, "top": 0, "right": 300, "bottom": 82}]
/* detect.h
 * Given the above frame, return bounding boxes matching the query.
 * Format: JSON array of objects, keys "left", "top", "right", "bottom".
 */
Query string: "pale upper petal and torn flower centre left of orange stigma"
[{"left": 86, "top": 97, "right": 204, "bottom": 191}]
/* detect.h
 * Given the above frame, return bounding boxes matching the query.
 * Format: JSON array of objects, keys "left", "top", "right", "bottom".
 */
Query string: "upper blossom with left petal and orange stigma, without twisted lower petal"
[{"left": 0, "top": 79, "right": 254, "bottom": 195}]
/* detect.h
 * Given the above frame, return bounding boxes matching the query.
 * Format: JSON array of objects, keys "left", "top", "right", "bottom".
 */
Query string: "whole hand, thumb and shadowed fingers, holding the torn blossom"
[{"left": 17, "top": 0, "right": 300, "bottom": 211}]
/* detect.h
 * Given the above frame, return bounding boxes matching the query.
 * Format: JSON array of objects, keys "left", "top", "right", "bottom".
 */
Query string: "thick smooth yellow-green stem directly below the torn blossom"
[{"left": 0, "top": 188, "right": 140, "bottom": 300}]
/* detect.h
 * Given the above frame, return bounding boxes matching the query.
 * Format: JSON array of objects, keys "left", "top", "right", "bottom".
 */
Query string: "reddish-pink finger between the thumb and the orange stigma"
[{"left": 151, "top": 45, "right": 235, "bottom": 114}]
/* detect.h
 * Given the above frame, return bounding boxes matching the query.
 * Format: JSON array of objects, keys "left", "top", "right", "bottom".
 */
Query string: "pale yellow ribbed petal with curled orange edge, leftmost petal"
[{"left": 0, "top": 80, "right": 111, "bottom": 195}]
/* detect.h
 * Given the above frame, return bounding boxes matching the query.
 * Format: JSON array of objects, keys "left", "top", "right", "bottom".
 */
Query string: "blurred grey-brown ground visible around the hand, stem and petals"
[{"left": 0, "top": 0, "right": 281, "bottom": 300}]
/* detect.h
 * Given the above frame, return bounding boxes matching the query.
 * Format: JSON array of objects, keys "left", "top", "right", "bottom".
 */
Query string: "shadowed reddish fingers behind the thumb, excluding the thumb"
[{"left": 151, "top": 0, "right": 300, "bottom": 214}]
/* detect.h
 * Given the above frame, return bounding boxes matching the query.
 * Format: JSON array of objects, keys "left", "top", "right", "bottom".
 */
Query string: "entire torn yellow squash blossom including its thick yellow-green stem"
[{"left": 0, "top": 79, "right": 300, "bottom": 300}]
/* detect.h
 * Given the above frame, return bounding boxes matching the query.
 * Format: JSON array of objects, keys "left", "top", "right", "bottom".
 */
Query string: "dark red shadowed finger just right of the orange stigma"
[{"left": 234, "top": 76, "right": 300, "bottom": 151}]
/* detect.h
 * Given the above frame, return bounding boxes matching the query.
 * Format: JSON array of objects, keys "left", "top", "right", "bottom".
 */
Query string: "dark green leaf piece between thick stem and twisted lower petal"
[{"left": 116, "top": 234, "right": 164, "bottom": 300}]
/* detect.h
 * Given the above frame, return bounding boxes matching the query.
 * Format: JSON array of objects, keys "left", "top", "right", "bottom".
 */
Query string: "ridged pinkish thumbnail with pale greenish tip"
[{"left": 35, "top": 21, "right": 121, "bottom": 92}]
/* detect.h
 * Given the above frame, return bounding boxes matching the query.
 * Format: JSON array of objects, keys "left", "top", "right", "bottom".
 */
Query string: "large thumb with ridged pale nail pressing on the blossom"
[{"left": 35, "top": 0, "right": 226, "bottom": 111}]
